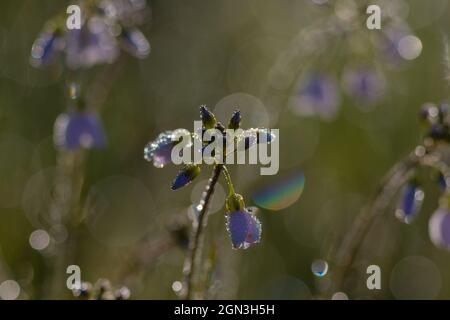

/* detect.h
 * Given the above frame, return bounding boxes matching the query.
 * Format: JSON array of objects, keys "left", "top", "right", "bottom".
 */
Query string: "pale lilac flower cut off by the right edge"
[{"left": 428, "top": 208, "right": 450, "bottom": 250}]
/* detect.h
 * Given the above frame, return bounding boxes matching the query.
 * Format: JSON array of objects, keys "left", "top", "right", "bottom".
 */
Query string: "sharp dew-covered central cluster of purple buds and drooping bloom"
[{"left": 144, "top": 106, "right": 275, "bottom": 249}]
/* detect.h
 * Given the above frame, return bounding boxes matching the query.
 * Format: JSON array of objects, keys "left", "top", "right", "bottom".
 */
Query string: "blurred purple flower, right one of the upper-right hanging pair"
[{"left": 343, "top": 67, "right": 385, "bottom": 104}]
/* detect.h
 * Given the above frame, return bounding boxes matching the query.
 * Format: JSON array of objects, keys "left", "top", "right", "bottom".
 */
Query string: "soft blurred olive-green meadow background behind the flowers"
[{"left": 0, "top": 0, "right": 450, "bottom": 299}]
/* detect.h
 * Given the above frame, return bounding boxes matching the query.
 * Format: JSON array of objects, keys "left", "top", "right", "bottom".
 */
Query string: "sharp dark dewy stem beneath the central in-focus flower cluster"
[{"left": 183, "top": 164, "right": 223, "bottom": 299}]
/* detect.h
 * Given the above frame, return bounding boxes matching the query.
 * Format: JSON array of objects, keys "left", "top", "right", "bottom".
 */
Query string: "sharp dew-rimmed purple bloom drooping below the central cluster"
[{"left": 227, "top": 208, "right": 261, "bottom": 249}]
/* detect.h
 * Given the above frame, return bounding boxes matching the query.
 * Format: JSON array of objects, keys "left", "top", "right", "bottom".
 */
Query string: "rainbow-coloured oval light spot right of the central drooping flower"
[{"left": 253, "top": 172, "right": 305, "bottom": 211}]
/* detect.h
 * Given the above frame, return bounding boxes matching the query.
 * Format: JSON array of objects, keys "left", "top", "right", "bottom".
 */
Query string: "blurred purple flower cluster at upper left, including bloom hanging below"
[{"left": 30, "top": 0, "right": 150, "bottom": 151}]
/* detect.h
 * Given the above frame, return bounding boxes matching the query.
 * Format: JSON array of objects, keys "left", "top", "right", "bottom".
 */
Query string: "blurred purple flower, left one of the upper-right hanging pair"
[{"left": 293, "top": 73, "right": 340, "bottom": 120}]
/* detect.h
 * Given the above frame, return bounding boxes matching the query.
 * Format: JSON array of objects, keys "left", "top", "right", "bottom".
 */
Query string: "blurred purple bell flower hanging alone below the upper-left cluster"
[{"left": 54, "top": 112, "right": 106, "bottom": 150}]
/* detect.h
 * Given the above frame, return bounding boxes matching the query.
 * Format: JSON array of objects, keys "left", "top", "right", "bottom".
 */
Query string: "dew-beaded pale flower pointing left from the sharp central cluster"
[{"left": 144, "top": 129, "right": 190, "bottom": 168}]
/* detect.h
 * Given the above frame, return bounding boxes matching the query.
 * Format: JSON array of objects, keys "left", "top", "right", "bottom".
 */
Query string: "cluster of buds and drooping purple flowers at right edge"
[{"left": 395, "top": 103, "right": 450, "bottom": 250}]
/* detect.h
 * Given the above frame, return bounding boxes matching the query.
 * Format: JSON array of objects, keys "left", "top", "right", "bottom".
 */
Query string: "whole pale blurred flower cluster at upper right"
[{"left": 291, "top": 1, "right": 422, "bottom": 120}]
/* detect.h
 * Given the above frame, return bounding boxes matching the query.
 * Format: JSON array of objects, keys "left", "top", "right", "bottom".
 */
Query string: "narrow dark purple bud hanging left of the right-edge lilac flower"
[{"left": 395, "top": 182, "right": 424, "bottom": 223}]
